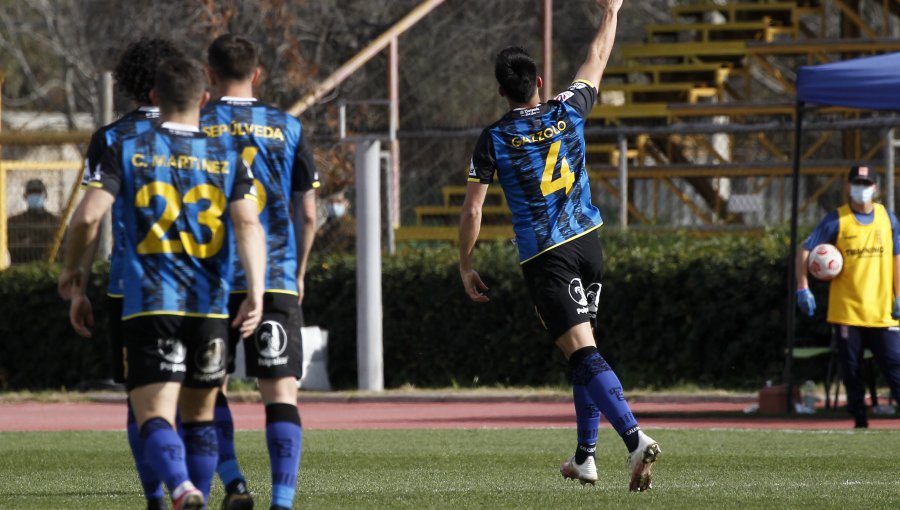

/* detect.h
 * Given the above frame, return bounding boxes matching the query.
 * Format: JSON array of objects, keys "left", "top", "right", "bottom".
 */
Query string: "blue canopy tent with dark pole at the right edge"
[{"left": 784, "top": 52, "right": 900, "bottom": 409}]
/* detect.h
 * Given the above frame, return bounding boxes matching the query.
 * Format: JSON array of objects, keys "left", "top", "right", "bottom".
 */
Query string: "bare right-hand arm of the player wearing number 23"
[{"left": 230, "top": 199, "right": 266, "bottom": 338}]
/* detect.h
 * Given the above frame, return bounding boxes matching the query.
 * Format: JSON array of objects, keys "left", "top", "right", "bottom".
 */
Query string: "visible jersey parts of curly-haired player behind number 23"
[{"left": 81, "top": 106, "right": 159, "bottom": 297}]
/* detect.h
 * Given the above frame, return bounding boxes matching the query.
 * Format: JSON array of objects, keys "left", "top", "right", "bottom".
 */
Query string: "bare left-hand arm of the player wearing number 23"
[{"left": 57, "top": 188, "right": 115, "bottom": 300}]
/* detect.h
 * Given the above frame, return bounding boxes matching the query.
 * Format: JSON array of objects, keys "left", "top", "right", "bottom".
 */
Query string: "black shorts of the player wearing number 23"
[{"left": 122, "top": 315, "right": 228, "bottom": 388}]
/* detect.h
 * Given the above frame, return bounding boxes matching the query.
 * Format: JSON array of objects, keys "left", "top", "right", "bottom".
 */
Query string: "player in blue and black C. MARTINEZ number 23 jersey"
[{"left": 59, "top": 58, "right": 265, "bottom": 510}]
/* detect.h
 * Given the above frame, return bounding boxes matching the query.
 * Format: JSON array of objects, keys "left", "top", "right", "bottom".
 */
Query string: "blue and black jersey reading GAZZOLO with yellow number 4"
[{"left": 469, "top": 80, "right": 603, "bottom": 262}]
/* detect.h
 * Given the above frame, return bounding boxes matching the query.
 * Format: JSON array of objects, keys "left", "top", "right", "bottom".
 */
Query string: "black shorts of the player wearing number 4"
[{"left": 522, "top": 231, "right": 603, "bottom": 341}]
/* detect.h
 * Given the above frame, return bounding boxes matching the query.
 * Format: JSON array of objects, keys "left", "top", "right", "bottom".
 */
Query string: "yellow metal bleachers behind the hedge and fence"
[{"left": 397, "top": 0, "right": 900, "bottom": 240}]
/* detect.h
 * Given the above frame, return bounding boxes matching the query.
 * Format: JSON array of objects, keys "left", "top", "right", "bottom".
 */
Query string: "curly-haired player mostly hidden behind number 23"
[{"left": 69, "top": 39, "right": 182, "bottom": 510}]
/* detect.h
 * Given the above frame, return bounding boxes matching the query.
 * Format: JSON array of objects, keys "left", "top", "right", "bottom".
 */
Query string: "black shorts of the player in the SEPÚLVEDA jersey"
[{"left": 228, "top": 292, "right": 303, "bottom": 379}]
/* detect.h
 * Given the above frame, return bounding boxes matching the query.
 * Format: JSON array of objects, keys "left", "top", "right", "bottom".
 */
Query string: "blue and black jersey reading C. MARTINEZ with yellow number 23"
[{"left": 90, "top": 124, "right": 255, "bottom": 319}]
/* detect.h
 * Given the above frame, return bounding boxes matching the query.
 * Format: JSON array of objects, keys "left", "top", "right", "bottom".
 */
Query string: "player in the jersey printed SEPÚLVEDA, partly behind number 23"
[{"left": 201, "top": 34, "right": 319, "bottom": 509}]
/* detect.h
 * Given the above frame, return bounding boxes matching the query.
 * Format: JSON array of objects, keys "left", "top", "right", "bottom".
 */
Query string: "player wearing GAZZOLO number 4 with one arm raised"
[{"left": 459, "top": 0, "right": 660, "bottom": 491}]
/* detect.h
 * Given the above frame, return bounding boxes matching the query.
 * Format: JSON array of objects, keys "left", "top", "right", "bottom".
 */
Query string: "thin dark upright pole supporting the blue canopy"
[{"left": 784, "top": 101, "right": 803, "bottom": 412}]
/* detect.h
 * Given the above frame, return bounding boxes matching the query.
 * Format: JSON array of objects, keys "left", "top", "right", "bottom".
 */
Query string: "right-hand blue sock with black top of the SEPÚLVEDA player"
[{"left": 266, "top": 404, "right": 303, "bottom": 508}]
